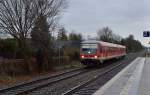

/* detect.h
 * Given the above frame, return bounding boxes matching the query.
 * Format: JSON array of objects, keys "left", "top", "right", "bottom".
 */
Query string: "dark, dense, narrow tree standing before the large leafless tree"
[{"left": 31, "top": 15, "right": 52, "bottom": 71}]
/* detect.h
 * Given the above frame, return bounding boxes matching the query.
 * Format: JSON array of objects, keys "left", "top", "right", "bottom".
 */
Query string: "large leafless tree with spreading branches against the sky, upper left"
[{"left": 0, "top": 0, "right": 65, "bottom": 57}]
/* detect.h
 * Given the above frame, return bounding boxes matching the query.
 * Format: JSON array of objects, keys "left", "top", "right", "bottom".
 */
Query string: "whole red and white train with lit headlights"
[{"left": 80, "top": 41, "right": 126, "bottom": 66}]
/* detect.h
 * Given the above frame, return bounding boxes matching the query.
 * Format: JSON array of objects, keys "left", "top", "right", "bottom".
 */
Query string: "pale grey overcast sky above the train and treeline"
[{"left": 61, "top": 0, "right": 150, "bottom": 46}]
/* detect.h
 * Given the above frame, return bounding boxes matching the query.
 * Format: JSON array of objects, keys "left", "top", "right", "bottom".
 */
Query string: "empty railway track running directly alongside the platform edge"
[{"left": 62, "top": 52, "right": 144, "bottom": 95}]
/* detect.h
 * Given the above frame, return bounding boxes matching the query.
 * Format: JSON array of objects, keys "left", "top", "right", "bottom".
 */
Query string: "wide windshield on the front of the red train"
[{"left": 81, "top": 44, "right": 98, "bottom": 54}]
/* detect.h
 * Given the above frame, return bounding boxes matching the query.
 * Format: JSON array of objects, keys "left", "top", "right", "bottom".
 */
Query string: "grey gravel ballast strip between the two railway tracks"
[{"left": 28, "top": 60, "right": 127, "bottom": 95}]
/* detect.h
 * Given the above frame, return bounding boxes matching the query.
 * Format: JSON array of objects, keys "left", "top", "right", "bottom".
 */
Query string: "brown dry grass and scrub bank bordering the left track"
[{"left": 0, "top": 59, "right": 82, "bottom": 88}]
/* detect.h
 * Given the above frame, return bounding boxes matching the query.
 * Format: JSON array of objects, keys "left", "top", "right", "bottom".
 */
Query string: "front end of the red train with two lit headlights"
[{"left": 80, "top": 42, "right": 99, "bottom": 66}]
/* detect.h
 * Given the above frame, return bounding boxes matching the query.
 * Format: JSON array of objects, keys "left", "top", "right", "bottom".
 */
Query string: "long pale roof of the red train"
[{"left": 81, "top": 40, "right": 126, "bottom": 48}]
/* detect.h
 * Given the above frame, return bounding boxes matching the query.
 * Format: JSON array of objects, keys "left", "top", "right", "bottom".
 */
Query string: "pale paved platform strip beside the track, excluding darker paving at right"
[{"left": 93, "top": 57, "right": 145, "bottom": 95}]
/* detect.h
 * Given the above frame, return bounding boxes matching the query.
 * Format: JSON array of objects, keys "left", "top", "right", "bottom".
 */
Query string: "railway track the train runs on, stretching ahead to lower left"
[{"left": 0, "top": 68, "right": 87, "bottom": 95}]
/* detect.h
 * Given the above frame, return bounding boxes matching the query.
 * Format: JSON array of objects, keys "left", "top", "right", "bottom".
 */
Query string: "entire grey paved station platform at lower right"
[{"left": 93, "top": 57, "right": 150, "bottom": 95}]
